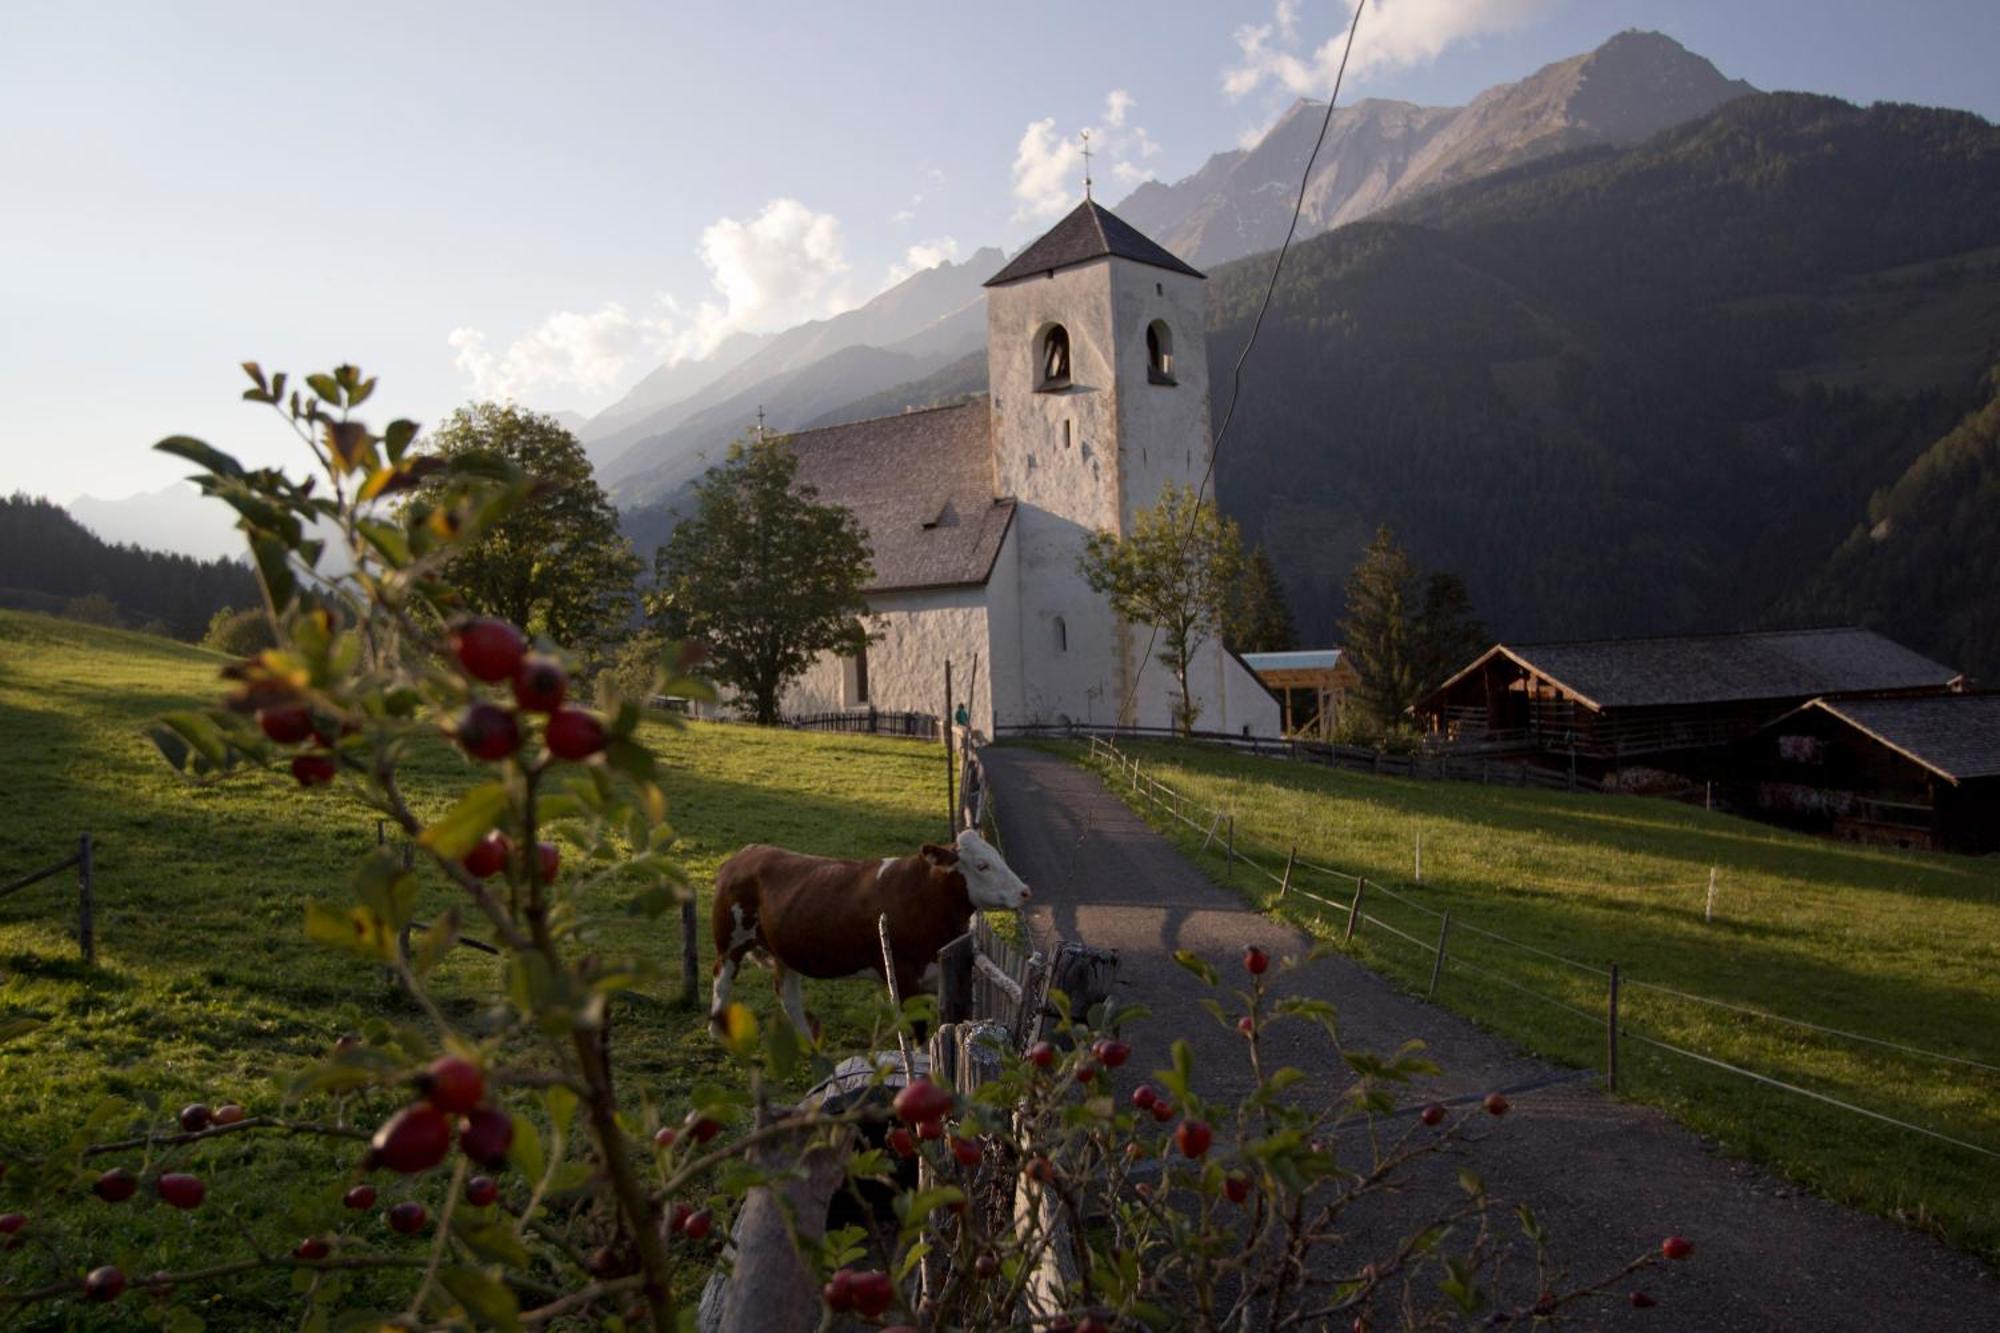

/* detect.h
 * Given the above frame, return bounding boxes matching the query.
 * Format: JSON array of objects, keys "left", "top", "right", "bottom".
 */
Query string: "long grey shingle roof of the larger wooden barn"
[{"left": 1434, "top": 628, "right": 1958, "bottom": 709}]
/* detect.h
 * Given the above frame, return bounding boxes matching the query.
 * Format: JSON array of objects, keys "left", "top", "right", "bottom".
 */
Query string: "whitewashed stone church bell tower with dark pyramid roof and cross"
[{"left": 986, "top": 198, "right": 1222, "bottom": 727}]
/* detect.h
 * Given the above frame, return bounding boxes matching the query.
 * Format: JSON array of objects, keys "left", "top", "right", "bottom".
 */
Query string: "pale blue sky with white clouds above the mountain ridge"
[{"left": 0, "top": 0, "right": 2000, "bottom": 502}]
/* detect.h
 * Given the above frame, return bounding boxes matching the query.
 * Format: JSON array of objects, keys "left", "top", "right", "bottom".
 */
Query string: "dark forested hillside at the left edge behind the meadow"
[{"left": 0, "top": 494, "right": 258, "bottom": 640}]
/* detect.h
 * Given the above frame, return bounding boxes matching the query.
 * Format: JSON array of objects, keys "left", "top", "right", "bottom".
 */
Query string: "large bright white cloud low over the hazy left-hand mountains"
[{"left": 448, "top": 198, "right": 856, "bottom": 398}]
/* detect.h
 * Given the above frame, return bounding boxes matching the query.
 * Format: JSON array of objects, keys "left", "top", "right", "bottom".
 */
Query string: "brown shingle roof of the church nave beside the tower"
[{"left": 790, "top": 398, "right": 1014, "bottom": 592}]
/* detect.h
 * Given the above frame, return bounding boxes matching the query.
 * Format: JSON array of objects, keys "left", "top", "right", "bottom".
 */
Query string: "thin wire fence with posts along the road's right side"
[{"left": 1088, "top": 737, "right": 2000, "bottom": 1159}]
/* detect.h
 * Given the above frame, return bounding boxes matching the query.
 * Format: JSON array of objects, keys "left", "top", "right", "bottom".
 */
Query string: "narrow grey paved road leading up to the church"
[{"left": 984, "top": 747, "right": 2000, "bottom": 1333}]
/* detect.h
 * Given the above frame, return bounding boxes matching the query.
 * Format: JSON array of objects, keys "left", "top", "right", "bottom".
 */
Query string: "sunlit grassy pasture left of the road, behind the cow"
[{"left": 0, "top": 612, "right": 960, "bottom": 1327}]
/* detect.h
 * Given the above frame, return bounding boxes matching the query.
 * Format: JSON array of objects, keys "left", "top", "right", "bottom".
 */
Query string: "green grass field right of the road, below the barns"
[{"left": 1076, "top": 745, "right": 2000, "bottom": 1259}]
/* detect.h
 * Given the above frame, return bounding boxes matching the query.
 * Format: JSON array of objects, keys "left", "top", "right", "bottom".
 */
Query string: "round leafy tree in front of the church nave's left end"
[{"left": 646, "top": 438, "right": 872, "bottom": 725}]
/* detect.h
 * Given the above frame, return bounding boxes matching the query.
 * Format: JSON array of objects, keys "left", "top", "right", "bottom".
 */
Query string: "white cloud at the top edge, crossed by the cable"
[{"left": 1222, "top": 0, "right": 1562, "bottom": 98}]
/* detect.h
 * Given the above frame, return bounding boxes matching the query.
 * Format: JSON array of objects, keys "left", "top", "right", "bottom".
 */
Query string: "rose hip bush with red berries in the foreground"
[{"left": 0, "top": 364, "right": 1692, "bottom": 1333}]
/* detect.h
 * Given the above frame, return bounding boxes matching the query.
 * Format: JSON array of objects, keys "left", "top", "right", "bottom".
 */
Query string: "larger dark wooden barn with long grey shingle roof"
[{"left": 1416, "top": 628, "right": 1962, "bottom": 775}]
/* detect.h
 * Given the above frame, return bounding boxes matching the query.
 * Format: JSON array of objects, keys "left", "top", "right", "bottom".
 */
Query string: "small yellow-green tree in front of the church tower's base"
[{"left": 1082, "top": 482, "right": 1244, "bottom": 735}]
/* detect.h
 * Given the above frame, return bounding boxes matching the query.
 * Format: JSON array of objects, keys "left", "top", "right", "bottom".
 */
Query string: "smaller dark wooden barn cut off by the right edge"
[{"left": 1738, "top": 695, "right": 2000, "bottom": 853}]
